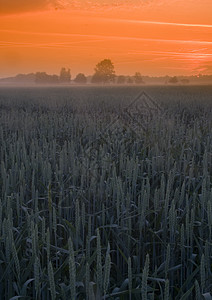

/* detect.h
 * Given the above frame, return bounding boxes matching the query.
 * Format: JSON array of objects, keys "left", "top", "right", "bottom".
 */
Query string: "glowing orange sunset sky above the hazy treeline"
[{"left": 0, "top": 0, "right": 212, "bottom": 77}]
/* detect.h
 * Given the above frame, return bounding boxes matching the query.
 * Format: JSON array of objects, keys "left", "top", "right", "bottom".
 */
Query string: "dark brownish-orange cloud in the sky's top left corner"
[{"left": 0, "top": 0, "right": 61, "bottom": 15}]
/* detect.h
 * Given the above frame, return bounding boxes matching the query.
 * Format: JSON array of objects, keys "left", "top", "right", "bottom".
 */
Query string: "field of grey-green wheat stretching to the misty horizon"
[{"left": 0, "top": 86, "right": 212, "bottom": 300}]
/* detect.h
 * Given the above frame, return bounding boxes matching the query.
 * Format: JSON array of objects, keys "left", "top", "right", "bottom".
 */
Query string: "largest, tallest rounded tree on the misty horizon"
[{"left": 92, "top": 59, "right": 115, "bottom": 83}]
